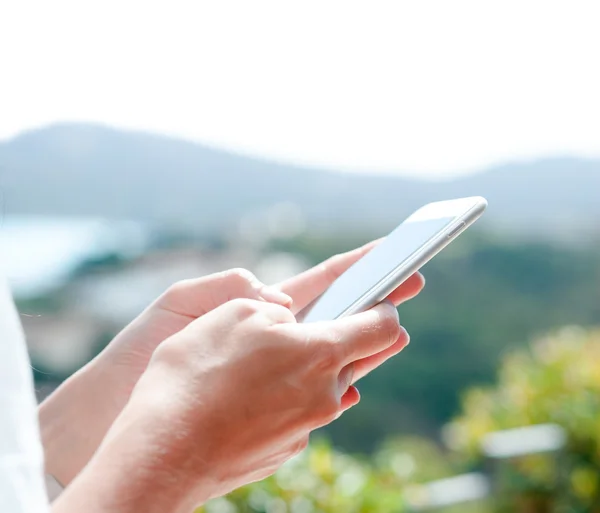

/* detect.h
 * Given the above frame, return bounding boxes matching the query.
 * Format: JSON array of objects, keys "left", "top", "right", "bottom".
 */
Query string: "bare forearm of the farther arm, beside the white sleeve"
[{"left": 38, "top": 354, "right": 124, "bottom": 486}]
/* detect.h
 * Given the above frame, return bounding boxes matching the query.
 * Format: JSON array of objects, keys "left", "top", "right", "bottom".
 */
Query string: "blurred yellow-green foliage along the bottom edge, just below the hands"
[{"left": 197, "top": 438, "right": 449, "bottom": 513}]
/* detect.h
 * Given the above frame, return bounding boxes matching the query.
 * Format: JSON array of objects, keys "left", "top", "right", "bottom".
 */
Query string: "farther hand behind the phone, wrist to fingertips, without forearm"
[{"left": 104, "top": 241, "right": 425, "bottom": 404}]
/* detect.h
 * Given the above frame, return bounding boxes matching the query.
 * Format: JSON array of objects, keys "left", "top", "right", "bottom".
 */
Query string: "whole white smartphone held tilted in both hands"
[{"left": 298, "top": 196, "right": 487, "bottom": 322}]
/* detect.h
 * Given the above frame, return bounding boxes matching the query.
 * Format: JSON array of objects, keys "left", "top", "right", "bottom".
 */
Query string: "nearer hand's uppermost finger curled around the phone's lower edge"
[{"left": 304, "top": 300, "right": 401, "bottom": 364}]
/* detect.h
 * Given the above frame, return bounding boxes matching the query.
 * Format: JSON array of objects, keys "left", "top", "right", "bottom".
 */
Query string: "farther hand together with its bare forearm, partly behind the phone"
[{"left": 40, "top": 242, "right": 424, "bottom": 485}]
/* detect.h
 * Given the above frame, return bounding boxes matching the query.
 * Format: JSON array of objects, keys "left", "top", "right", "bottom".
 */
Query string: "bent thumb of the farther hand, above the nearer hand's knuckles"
[{"left": 156, "top": 269, "right": 292, "bottom": 319}]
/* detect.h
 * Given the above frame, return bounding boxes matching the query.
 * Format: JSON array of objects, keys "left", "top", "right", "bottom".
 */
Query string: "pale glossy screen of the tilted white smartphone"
[{"left": 303, "top": 216, "right": 456, "bottom": 322}]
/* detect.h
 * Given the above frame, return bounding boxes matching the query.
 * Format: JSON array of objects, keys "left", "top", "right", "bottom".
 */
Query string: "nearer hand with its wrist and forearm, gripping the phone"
[{"left": 56, "top": 300, "right": 406, "bottom": 513}]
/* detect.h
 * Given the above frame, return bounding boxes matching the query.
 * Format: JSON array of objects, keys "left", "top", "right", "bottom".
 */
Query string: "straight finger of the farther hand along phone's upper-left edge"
[{"left": 278, "top": 239, "right": 381, "bottom": 312}]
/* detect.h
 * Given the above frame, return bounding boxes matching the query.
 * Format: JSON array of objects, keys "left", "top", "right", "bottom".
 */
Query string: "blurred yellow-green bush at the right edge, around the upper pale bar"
[{"left": 448, "top": 328, "right": 600, "bottom": 513}]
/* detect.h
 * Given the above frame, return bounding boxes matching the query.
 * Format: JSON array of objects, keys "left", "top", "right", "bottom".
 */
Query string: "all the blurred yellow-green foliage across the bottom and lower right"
[{"left": 201, "top": 328, "right": 600, "bottom": 513}]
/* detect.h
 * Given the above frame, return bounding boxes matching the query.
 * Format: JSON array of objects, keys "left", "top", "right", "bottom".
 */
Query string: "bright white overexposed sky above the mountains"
[{"left": 0, "top": 0, "right": 600, "bottom": 179}]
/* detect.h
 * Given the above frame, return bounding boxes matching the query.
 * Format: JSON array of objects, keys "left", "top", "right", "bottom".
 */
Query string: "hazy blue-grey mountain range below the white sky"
[{"left": 0, "top": 124, "right": 600, "bottom": 236}]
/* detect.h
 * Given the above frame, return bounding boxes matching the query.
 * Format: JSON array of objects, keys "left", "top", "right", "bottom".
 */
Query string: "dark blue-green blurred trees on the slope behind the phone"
[{"left": 268, "top": 233, "right": 600, "bottom": 452}]
